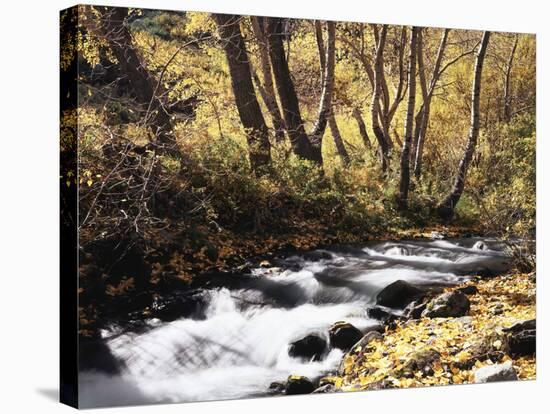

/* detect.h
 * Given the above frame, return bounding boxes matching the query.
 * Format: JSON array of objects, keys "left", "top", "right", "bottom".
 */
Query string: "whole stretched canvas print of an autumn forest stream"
[{"left": 60, "top": 5, "right": 536, "bottom": 408}]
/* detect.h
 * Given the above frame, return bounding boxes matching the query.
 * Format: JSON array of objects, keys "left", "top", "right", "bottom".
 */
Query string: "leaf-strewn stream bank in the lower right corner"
[{"left": 323, "top": 272, "right": 536, "bottom": 391}]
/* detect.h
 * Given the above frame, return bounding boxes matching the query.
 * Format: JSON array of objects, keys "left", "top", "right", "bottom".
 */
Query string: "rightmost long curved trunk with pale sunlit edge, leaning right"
[{"left": 437, "top": 32, "right": 490, "bottom": 219}]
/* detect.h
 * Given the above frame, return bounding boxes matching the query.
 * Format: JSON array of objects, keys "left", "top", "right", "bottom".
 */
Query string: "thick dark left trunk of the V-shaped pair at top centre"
[{"left": 266, "top": 17, "right": 322, "bottom": 165}]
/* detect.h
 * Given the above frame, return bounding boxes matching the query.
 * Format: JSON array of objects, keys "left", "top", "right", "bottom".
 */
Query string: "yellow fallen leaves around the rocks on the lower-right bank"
[{"left": 342, "top": 274, "right": 536, "bottom": 390}]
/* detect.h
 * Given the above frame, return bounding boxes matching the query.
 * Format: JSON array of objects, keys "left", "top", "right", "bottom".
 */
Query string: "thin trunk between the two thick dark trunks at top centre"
[{"left": 251, "top": 17, "right": 285, "bottom": 142}]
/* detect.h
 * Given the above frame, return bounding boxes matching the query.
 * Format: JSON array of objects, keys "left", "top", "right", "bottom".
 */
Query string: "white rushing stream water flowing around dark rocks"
[{"left": 79, "top": 238, "right": 508, "bottom": 407}]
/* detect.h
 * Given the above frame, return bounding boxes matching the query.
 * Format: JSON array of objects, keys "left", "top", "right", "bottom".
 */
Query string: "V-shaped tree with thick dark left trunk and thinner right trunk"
[{"left": 265, "top": 18, "right": 336, "bottom": 165}]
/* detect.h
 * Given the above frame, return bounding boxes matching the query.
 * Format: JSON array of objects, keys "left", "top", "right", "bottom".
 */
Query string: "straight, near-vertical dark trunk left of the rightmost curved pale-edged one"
[{"left": 397, "top": 27, "right": 420, "bottom": 208}]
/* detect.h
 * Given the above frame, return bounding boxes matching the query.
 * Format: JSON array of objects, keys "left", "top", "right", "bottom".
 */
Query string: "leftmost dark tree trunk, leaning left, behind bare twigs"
[{"left": 97, "top": 7, "right": 178, "bottom": 154}]
